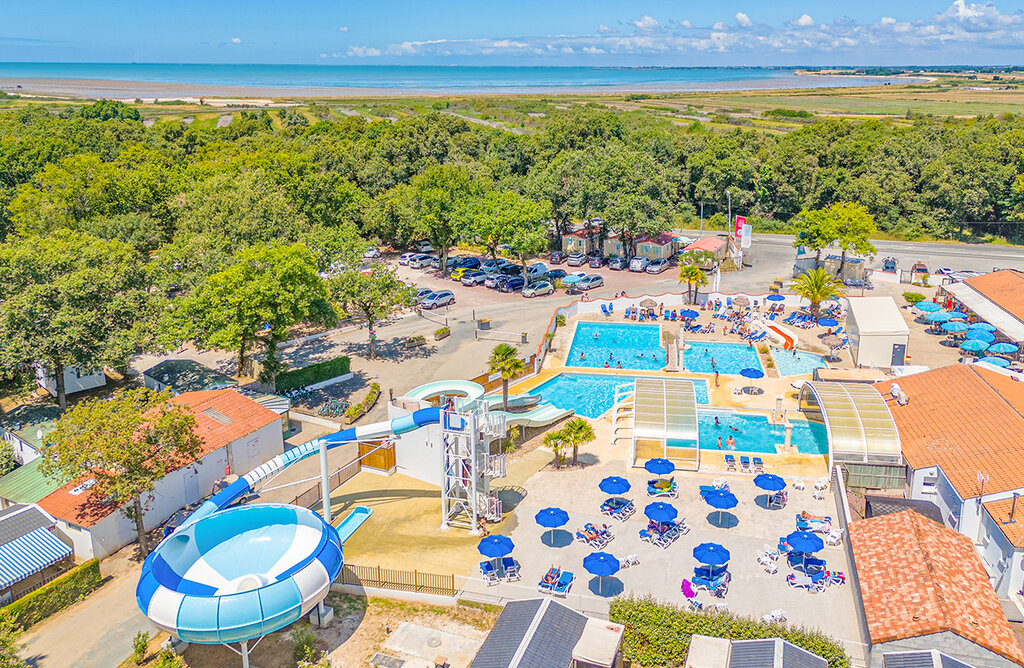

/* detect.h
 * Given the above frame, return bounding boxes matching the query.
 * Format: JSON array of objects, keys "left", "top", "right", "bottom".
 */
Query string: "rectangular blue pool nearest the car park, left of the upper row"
[{"left": 565, "top": 323, "right": 665, "bottom": 371}]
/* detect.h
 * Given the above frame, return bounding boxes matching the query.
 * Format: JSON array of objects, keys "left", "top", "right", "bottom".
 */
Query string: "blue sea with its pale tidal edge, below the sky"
[{"left": 0, "top": 62, "right": 913, "bottom": 94}]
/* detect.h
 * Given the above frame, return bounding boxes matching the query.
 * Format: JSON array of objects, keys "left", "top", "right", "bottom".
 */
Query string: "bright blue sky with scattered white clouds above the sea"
[{"left": 0, "top": 0, "right": 1024, "bottom": 67}]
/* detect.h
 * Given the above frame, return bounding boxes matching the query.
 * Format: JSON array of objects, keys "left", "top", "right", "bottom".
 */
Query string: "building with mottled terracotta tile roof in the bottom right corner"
[{"left": 849, "top": 510, "right": 1024, "bottom": 667}]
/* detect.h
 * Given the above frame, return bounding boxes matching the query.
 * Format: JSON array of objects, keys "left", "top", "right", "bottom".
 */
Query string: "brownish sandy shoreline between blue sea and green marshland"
[{"left": 0, "top": 73, "right": 927, "bottom": 102}]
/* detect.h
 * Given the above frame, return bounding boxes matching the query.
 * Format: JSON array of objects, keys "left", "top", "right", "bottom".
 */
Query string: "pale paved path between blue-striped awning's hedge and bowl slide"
[{"left": 22, "top": 545, "right": 157, "bottom": 668}]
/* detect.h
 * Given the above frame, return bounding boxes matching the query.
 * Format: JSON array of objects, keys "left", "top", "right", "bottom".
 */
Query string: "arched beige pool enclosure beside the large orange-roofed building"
[{"left": 800, "top": 380, "right": 903, "bottom": 479}]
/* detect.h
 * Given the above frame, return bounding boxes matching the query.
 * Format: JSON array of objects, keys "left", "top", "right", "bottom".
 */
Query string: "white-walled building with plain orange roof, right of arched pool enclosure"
[{"left": 874, "top": 365, "right": 1024, "bottom": 603}]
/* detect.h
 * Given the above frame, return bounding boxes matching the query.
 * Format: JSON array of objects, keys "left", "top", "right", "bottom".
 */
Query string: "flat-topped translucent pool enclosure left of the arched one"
[{"left": 614, "top": 377, "right": 700, "bottom": 469}]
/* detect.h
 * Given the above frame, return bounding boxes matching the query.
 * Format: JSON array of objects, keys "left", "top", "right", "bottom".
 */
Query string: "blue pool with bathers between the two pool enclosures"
[{"left": 697, "top": 410, "right": 828, "bottom": 455}]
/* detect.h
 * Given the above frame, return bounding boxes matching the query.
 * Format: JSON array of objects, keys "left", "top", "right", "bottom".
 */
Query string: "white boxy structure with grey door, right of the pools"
[{"left": 846, "top": 297, "right": 910, "bottom": 369}]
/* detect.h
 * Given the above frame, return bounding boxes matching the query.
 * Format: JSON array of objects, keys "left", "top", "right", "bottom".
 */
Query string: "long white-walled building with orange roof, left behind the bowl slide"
[{"left": 39, "top": 389, "right": 284, "bottom": 559}]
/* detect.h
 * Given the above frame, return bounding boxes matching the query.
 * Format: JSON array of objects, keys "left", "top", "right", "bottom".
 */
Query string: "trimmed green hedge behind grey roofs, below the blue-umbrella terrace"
[{"left": 608, "top": 596, "right": 850, "bottom": 668}]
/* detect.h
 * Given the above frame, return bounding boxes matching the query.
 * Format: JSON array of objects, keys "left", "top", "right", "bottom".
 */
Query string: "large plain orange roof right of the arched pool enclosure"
[{"left": 874, "top": 364, "right": 1024, "bottom": 499}]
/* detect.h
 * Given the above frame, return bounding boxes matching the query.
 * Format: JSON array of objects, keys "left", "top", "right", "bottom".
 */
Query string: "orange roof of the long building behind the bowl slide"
[{"left": 39, "top": 389, "right": 281, "bottom": 529}]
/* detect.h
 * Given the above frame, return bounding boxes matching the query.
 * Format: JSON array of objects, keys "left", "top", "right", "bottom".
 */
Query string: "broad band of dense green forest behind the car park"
[{"left": 0, "top": 96, "right": 1024, "bottom": 404}]
